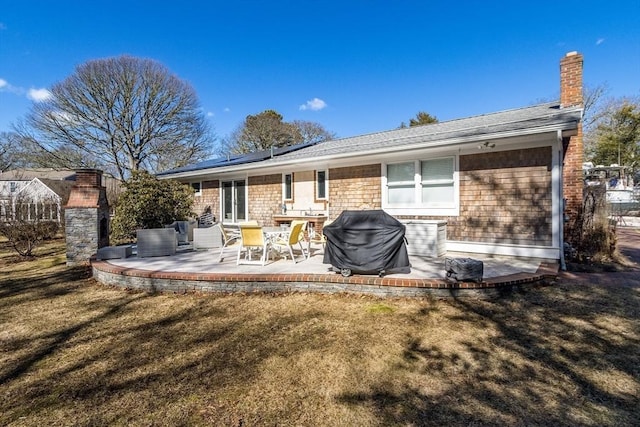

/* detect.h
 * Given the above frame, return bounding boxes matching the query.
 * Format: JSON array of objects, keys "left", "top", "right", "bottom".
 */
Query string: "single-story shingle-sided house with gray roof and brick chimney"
[{"left": 158, "top": 52, "right": 583, "bottom": 260}]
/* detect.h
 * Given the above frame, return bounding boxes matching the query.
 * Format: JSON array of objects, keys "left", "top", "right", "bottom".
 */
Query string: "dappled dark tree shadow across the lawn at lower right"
[{"left": 339, "top": 285, "right": 640, "bottom": 426}]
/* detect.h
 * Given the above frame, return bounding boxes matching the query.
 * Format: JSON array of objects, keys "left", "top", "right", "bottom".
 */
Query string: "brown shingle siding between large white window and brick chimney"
[{"left": 401, "top": 147, "right": 552, "bottom": 246}]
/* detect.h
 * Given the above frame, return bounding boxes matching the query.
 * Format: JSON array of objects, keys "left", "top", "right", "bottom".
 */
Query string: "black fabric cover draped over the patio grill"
[{"left": 323, "top": 210, "right": 411, "bottom": 274}]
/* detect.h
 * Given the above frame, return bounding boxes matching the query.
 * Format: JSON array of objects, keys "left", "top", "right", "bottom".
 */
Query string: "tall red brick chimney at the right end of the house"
[{"left": 560, "top": 52, "right": 584, "bottom": 241}]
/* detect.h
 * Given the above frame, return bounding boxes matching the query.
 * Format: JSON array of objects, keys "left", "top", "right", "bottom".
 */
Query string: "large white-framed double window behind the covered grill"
[{"left": 382, "top": 156, "right": 459, "bottom": 216}]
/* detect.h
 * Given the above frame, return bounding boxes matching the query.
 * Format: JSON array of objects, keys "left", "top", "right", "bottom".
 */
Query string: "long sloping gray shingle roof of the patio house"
[{"left": 161, "top": 102, "right": 582, "bottom": 176}]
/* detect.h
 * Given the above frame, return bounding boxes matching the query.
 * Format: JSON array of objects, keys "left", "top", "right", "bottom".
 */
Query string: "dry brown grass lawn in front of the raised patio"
[{"left": 0, "top": 242, "right": 640, "bottom": 426}]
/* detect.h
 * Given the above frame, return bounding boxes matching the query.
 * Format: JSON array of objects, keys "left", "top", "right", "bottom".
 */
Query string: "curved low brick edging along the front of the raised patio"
[{"left": 91, "top": 259, "right": 558, "bottom": 296}]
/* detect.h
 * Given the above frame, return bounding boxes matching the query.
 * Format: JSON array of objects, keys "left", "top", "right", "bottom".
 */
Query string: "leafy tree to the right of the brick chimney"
[{"left": 585, "top": 99, "right": 640, "bottom": 169}]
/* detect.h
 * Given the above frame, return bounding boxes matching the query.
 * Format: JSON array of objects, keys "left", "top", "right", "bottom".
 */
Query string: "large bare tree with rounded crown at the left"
[{"left": 22, "top": 56, "right": 211, "bottom": 179}]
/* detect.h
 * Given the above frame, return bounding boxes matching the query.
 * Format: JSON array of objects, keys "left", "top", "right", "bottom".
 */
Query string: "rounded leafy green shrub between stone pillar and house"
[{"left": 110, "top": 171, "right": 195, "bottom": 242}]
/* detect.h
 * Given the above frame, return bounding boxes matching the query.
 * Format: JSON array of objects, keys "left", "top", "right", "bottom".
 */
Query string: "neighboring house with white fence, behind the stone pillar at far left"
[{"left": 0, "top": 168, "right": 119, "bottom": 222}]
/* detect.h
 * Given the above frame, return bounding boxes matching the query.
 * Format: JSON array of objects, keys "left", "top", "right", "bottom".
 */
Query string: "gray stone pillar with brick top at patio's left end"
[{"left": 64, "top": 169, "right": 109, "bottom": 266}]
